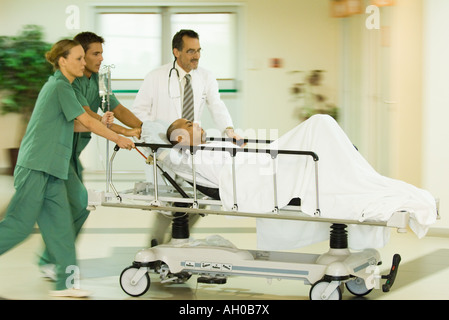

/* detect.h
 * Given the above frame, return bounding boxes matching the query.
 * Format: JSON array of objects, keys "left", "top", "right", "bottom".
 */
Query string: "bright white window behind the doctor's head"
[{"left": 94, "top": 6, "right": 238, "bottom": 80}]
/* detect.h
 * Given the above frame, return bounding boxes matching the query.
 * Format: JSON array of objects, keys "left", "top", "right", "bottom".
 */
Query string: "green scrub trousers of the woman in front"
[{"left": 0, "top": 166, "right": 76, "bottom": 290}]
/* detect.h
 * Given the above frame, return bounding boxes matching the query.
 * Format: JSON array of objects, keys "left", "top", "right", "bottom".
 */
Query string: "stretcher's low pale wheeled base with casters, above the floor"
[{"left": 120, "top": 235, "right": 397, "bottom": 300}]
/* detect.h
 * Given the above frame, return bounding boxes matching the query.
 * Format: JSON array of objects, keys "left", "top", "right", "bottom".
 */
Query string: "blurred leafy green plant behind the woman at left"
[{"left": 0, "top": 25, "right": 53, "bottom": 121}]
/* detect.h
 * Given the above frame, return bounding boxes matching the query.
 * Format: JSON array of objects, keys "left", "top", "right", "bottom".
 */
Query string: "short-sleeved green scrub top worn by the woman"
[{"left": 17, "top": 70, "right": 85, "bottom": 180}]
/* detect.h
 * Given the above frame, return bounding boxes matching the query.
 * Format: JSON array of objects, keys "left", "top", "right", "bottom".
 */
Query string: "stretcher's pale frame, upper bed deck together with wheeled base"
[{"left": 90, "top": 185, "right": 402, "bottom": 300}]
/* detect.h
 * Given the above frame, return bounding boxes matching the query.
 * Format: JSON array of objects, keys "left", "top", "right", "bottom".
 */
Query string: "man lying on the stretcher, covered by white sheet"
[{"left": 158, "top": 115, "right": 437, "bottom": 250}]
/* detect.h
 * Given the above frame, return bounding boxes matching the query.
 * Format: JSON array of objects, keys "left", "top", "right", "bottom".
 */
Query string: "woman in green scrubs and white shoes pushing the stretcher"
[{"left": 0, "top": 40, "right": 135, "bottom": 297}]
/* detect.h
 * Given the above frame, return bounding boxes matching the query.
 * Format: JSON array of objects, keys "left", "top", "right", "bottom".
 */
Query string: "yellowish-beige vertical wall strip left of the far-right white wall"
[{"left": 390, "top": 0, "right": 424, "bottom": 186}]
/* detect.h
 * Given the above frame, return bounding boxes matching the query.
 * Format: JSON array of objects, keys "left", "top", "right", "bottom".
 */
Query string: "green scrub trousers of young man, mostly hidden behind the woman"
[{"left": 38, "top": 160, "right": 90, "bottom": 266}]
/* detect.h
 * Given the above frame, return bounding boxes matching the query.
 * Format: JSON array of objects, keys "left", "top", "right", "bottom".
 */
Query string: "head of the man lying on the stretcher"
[{"left": 167, "top": 119, "right": 206, "bottom": 146}]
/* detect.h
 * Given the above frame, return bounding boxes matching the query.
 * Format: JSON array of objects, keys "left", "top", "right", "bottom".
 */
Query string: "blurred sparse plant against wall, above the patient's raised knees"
[{"left": 290, "top": 70, "right": 339, "bottom": 121}]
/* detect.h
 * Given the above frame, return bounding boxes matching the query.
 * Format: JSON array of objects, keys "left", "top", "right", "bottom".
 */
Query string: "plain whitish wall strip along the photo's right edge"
[{"left": 422, "top": 0, "right": 449, "bottom": 234}]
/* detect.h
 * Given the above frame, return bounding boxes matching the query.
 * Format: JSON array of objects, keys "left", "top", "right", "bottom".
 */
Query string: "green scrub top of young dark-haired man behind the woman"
[{"left": 72, "top": 73, "right": 120, "bottom": 161}]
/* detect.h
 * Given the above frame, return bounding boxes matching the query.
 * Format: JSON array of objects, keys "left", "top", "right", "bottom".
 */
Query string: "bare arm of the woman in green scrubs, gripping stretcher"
[{"left": 75, "top": 112, "right": 135, "bottom": 150}]
